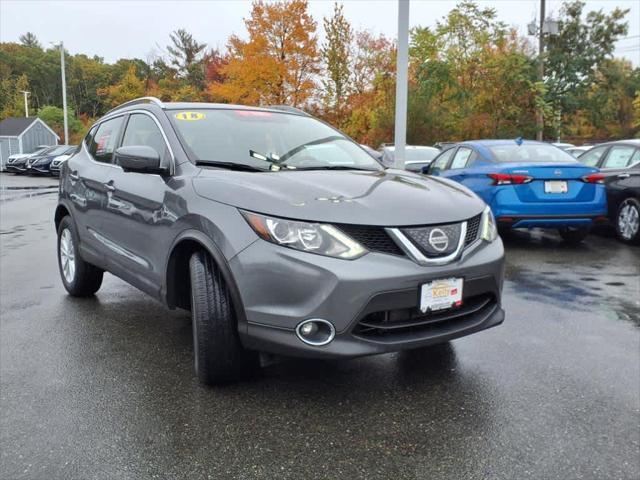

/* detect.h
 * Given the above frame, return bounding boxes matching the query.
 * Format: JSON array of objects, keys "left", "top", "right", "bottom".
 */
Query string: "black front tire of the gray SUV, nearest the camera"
[{"left": 189, "top": 252, "right": 258, "bottom": 385}]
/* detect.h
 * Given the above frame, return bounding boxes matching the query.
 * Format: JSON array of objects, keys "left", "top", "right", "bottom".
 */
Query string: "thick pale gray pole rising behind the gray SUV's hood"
[{"left": 394, "top": 0, "right": 409, "bottom": 169}]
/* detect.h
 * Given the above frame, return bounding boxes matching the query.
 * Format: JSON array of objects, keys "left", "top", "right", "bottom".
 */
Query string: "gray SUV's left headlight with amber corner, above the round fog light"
[{"left": 241, "top": 212, "right": 367, "bottom": 260}]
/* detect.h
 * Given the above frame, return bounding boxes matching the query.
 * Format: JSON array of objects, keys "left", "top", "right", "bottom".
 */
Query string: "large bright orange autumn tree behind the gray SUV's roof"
[{"left": 210, "top": 0, "right": 319, "bottom": 107}]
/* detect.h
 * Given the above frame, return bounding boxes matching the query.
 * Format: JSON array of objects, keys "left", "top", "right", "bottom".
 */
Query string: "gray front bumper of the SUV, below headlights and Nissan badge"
[{"left": 229, "top": 235, "right": 504, "bottom": 358}]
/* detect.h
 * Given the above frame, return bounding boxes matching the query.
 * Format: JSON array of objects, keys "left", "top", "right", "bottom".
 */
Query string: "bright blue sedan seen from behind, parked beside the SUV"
[{"left": 426, "top": 139, "right": 607, "bottom": 243}]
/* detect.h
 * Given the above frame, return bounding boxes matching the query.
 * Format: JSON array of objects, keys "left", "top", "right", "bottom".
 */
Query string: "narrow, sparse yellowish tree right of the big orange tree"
[{"left": 321, "top": 2, "right": 353, "bottom": 125}]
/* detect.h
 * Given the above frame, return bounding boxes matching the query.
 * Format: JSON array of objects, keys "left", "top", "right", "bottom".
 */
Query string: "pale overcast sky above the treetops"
[{"left": 0, "top": 0, "right": 640, "bottom": 66}]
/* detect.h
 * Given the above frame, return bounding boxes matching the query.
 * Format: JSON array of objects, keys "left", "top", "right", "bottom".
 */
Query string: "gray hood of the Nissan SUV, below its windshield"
[{"left": 193, "top": 169, "right": 485, "bottom": 226}]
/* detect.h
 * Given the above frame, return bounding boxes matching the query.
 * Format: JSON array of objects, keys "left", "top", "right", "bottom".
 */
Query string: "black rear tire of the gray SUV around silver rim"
[{"left": 58, "top": 215, "right": 104, "bottom": 297}]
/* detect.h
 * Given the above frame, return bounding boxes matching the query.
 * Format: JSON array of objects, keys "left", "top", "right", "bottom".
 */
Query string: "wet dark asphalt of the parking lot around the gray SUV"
[{"left": 0, "top": 174, "right": 640, "bottom": 480}]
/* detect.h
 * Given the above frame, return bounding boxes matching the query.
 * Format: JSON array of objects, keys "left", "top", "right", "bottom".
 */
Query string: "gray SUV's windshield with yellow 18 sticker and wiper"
[{"left": 169, "top": 109, "right": 382, "bottom": 170}]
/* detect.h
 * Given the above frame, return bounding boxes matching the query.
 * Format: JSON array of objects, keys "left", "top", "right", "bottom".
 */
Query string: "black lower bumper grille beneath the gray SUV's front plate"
[{"left": 352, "top": 293, "right": 497, "bottom": 342}]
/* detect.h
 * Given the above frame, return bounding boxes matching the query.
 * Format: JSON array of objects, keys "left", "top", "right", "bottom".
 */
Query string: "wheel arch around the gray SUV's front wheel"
[{"left": 163, "top": 230, "right": 247, "bottom": 329}]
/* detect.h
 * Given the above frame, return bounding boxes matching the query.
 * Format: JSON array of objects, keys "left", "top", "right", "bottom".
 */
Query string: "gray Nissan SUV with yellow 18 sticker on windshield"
[{"left": 55, "top": 98, "right": 504, "bottom": 384}]
